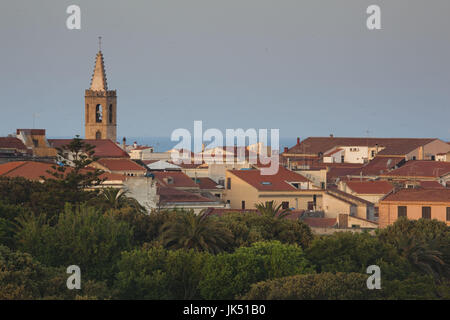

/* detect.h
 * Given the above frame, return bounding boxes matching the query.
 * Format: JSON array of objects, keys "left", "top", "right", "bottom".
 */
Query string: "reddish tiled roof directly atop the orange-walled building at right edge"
[{"left": 382, "top": 188, "right": 450, "bottom": 204}]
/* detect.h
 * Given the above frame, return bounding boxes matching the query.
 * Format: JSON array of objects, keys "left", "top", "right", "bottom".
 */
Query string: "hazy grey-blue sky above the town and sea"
[{"left": 0, "top": 0, "right": 450, "bottom": 140}]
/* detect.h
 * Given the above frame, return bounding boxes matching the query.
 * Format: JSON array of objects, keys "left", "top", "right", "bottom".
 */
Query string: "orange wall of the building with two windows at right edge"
[{"left": 378, "top": 201, "right": 450, "bottom": 228}]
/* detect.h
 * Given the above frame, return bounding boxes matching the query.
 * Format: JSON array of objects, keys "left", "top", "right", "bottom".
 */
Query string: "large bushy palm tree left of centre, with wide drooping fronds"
[{"left": 161, "top": 210, "right": 233, "bottom": 253}]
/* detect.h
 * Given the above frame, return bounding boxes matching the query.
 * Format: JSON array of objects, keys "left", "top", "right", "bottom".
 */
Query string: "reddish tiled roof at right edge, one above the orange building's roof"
[{"left": 380, "top": 160, "right": 450, "bottom": 178}]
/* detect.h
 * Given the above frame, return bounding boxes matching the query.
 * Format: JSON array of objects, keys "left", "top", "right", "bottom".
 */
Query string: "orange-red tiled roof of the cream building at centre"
[{"left": 229, "top": 167, "right": 309, "bottom": 191}]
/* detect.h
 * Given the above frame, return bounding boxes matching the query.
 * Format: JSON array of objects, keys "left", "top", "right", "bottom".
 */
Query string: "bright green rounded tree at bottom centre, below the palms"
[{"left": 199, "top": 241, "right": 313, "bottom": 299}]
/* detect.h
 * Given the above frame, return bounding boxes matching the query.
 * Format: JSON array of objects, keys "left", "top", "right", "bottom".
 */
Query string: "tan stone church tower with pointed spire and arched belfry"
[{"left": 84, "top": 42, "right": 117, "bottom": 142}]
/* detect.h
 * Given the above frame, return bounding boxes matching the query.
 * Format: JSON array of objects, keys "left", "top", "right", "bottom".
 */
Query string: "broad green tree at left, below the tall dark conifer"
[{"left": 16, "top": 205, "right": 132, "bottom": 280}]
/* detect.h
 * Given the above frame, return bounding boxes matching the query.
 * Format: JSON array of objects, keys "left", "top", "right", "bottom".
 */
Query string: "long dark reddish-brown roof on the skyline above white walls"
[{"left": 287, "top": 137, "right": 436, "bottom": 155}]
